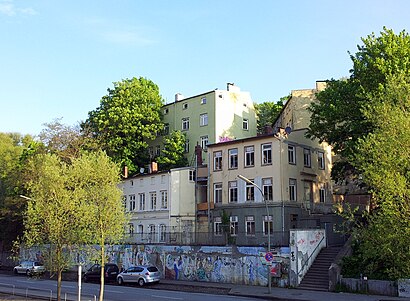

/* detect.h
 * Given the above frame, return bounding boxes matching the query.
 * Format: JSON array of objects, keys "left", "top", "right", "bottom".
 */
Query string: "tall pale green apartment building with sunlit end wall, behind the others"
[{"left": 150, "top": 83, "right": 256, "bottom": 166}]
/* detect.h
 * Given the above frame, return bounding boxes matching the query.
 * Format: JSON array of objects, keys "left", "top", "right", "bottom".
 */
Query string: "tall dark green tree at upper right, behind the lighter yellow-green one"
[{"left": 307, "top": 28, "right": 410, "bottom": 180}]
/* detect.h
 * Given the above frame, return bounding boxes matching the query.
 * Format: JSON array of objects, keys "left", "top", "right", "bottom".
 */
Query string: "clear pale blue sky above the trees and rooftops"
[{"left": 0, "top": 0, "right": 410, "bottom": 135}]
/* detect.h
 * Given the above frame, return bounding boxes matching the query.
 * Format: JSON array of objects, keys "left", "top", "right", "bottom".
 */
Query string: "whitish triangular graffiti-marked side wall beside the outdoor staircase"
[{"left": 289, "top": 229, "right": 326, "bottom": 287}]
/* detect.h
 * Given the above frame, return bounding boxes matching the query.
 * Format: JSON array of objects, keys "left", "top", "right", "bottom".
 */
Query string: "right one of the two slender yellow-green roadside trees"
[{"left": 70, "top": 152, "right": 127, "bottom": 301}]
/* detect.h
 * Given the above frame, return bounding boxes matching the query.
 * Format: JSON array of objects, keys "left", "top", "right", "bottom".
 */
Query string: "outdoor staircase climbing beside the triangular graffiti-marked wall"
[{"left": 298, "top": 247, "right": 342, "bottom": 291}]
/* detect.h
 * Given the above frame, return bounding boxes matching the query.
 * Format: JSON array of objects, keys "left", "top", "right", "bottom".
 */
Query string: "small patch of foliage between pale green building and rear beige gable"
[{"left": 254, "top": 95, "right": 290, "bottom": 134}]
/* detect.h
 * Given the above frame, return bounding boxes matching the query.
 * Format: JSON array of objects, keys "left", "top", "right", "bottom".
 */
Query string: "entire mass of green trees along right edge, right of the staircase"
[{"left": 309, "top": 28, "right": 410, "bottom": 279}]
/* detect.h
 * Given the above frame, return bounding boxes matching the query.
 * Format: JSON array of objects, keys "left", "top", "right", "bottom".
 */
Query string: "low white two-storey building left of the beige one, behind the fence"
[{"left": 121, "top": 167, "right": 195, "bottom": 243}]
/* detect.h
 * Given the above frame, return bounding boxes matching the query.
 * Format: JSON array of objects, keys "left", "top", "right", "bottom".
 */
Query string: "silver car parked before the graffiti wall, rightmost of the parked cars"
[{"left": 117, "top": 265, "right": 161, "bottom": 286}]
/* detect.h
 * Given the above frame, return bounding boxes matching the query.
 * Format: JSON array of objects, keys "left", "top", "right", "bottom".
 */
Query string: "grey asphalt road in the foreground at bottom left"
[{"left": 0, "top": 274, "right": 260, "bottom": 301}]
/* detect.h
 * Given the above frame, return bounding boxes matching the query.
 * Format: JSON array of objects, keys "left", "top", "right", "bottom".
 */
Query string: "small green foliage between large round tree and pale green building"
[{"left": 156, "top": 131, "right": 188, "bottom": 170}]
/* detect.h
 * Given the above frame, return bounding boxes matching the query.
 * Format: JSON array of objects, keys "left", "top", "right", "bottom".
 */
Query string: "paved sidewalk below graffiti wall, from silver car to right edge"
[{"left": 161, "top": 279, "right": 410, "bottom": 301}]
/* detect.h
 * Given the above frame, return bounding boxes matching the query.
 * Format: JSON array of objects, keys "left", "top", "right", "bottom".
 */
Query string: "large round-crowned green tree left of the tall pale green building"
[{"left": 82, "top": 77, "right": 163, "bottom": 173}]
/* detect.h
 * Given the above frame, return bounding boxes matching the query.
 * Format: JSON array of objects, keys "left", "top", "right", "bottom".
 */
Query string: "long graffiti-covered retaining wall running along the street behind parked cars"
[{"left": 22, "top": 245, "right": 289, "bottom": 287}]
